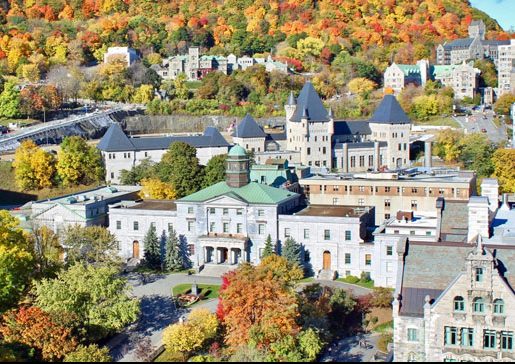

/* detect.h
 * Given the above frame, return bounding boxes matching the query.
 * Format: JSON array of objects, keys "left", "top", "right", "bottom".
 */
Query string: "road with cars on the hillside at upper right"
[{"left": 453, "top": 110, "right": 508, "bottom": 143}]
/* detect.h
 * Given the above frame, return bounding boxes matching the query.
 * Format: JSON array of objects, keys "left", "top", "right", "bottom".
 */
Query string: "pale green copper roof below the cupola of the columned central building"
[{"left": 179, "top": 182, "right": 298, "bottom": 205}]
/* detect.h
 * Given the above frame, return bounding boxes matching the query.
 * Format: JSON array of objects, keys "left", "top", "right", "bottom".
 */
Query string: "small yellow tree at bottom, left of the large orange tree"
[{"left": 163, "top": 308, "right": 218, "bottom": 355}]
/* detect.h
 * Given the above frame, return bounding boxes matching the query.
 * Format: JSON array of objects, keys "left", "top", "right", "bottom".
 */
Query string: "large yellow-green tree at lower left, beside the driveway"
[{"left": 34, "top": 263, "right": 139, "bottom": 340}]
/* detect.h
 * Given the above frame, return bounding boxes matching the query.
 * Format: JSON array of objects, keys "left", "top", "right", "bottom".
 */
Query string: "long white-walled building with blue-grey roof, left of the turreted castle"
[{"left": 97, "top": 124, "right": 229, "bottom": 183}]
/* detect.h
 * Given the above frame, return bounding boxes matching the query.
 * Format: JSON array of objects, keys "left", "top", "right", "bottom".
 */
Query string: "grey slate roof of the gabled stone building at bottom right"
[{"left": 400, "top": 242, "right": 515, "bottom": 316}]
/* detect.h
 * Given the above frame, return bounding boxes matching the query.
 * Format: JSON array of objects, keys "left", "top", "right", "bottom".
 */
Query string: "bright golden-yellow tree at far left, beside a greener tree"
[{"left": 13, "top": 139, "right": 55, "bottom": 190}]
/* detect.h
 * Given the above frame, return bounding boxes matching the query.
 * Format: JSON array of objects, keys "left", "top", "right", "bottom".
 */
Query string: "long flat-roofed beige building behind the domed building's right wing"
[{"left": 299, "top": 169, "right": 476, "bottom": 224}]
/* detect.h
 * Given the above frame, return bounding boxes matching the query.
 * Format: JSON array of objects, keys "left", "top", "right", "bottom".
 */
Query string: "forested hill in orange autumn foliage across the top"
[{"left": 0, "top": 0, "right": 508, "bottom": 75}]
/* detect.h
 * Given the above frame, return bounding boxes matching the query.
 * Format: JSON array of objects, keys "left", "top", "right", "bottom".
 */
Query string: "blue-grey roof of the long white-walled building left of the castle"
[{"left": 97, "top": 126, "right": 230, "bottom": 152}]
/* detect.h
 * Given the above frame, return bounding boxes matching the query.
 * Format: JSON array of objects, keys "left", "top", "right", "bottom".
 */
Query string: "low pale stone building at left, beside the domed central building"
[{"left": 13, "top": 186, "right": 140, "bottom": 232}]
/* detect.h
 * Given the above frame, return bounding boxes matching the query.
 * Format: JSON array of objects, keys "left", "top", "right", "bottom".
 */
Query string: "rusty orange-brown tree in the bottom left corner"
[{"left": 0, "top": 307, "right": 77, "bottom": 361}]
